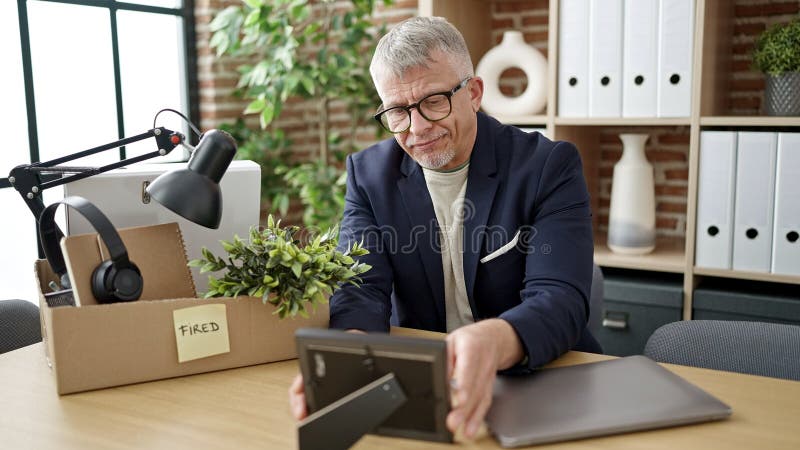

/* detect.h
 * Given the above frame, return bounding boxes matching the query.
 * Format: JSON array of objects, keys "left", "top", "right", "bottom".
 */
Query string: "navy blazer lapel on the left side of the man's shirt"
[{"left": 397, "top": 154, "right": 446, "bottom": 330}]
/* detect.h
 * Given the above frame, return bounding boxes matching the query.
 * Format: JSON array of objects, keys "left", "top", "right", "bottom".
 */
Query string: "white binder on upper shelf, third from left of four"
[{"left": 622, "top": 0, "right": 658, "bottom": 117}]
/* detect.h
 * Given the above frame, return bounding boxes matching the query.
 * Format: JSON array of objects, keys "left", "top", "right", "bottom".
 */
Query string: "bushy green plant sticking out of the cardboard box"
[{"left": 189, "top": 215, "right": 371, "bottom": 318}]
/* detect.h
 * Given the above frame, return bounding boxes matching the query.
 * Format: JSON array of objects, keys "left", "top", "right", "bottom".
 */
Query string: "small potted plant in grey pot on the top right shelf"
[{"left": 753, "top": 18, "right": 800, "bottom": 116}]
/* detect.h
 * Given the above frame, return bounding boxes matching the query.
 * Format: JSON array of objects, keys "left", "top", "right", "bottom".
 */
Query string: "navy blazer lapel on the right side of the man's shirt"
[{"left": 463, "top": 113, "right": 498, "bottom": 310}]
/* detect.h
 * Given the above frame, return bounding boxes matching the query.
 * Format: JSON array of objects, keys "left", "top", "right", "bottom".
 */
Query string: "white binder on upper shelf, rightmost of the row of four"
[{"left": 658, "top": 0, "right": 694, "bottom": 117}]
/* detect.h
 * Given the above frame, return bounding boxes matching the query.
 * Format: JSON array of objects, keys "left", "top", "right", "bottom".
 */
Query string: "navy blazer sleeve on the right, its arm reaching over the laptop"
[{"left": 499, "top": 142, "right": 594, "bottom": 369}]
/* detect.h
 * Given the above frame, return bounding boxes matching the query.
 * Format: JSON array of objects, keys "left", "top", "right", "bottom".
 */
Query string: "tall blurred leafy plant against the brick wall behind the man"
[{"left": 210, "top": 0, "right": 393, "bottom": 227}]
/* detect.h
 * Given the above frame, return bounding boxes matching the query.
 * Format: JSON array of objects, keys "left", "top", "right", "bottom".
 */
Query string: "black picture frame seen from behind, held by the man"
[{"left": 295, "top": 328, "right": 453, "bottom": 442}]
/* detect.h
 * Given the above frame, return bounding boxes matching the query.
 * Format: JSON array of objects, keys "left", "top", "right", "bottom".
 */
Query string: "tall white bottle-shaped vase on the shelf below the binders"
[{"left": 608, "top": 134, "right": 656, "bottom": 255}]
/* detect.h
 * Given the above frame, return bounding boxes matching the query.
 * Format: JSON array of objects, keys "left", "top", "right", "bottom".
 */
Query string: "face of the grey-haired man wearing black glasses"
[{"left": 375, "top": 51, "right": 483, "bottom": 170}]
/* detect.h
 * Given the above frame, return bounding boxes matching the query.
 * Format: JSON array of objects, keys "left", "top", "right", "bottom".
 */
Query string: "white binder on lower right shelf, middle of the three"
[{"left": 733, "top": 131, "right": 778, "bottom": 272}]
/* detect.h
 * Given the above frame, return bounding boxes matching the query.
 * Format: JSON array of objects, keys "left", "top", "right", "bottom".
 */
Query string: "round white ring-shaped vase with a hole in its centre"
[{"left": 475, "top": 31, "right": 547, "bottom": 116}]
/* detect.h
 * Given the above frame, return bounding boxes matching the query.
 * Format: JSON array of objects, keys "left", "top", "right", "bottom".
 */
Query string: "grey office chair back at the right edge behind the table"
[{"left": 644, "top": 320, "right": 800, "bottom": 380}]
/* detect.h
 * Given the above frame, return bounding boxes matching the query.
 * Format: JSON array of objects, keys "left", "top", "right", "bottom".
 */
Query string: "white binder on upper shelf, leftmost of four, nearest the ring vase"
[{"left": 558, "top": 0, "right": 589, "bottom": 117}]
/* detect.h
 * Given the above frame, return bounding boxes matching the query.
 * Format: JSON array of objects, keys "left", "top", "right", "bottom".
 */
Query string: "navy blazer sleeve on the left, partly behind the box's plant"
[{"left": 330, "top": 155, "right": 393, "bottom": 332}]
